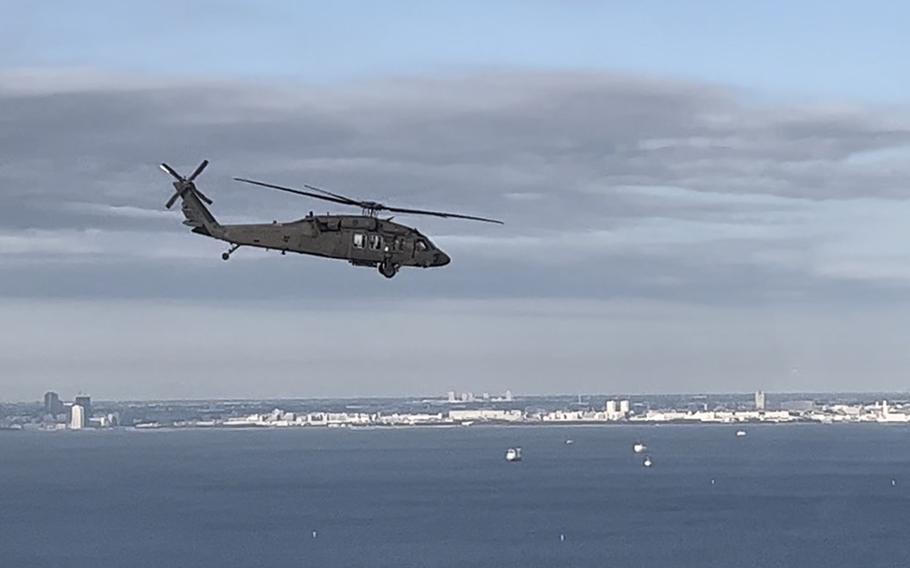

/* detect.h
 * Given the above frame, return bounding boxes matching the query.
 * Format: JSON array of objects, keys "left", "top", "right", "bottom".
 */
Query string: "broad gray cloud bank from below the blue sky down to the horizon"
[{"left": 0, "top": 69, "right": 910, "bottom": 398}]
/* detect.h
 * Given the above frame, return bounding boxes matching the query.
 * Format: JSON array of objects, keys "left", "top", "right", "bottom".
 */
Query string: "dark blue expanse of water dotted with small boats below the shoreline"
[{"left": 0, "top": 425, "right": 910, "bottom": 568}]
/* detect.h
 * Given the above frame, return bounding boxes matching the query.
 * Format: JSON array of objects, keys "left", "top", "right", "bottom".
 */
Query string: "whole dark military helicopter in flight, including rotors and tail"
[{"left": 161, "top": 160, "right": 502, "bottom": 278}]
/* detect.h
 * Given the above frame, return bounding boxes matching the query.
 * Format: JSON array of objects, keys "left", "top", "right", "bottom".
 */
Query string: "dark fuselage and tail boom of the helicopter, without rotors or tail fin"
[{"left": 206, "top": 214, "right": 449, "bottom": 268}]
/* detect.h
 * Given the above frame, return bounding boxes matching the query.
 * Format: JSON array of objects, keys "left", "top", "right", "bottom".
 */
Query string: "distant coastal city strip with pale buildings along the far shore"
[{"left": 0, "top": 391, "right": 910, "bottom": 430}]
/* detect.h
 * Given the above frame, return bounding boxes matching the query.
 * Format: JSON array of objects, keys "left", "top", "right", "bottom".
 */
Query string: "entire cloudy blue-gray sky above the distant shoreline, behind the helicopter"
[{"left": 0, "top": 1, "right": 910, "bottom": 401}]
